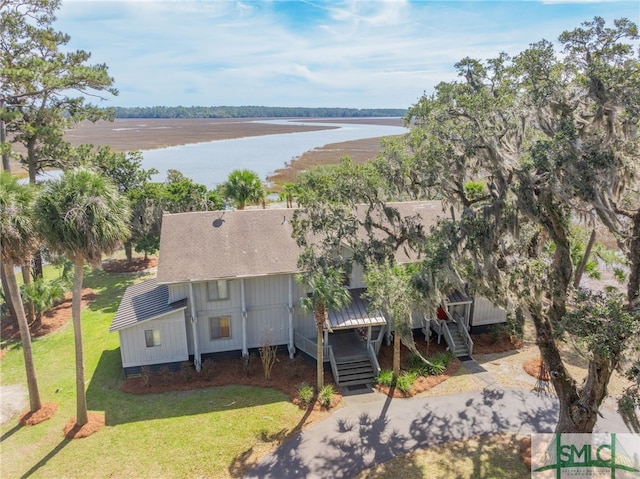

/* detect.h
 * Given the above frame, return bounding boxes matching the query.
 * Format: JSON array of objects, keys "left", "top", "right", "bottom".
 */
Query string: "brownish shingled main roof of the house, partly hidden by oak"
[{"left": 158, "top": 201, "right": 444, "bottom": 284}]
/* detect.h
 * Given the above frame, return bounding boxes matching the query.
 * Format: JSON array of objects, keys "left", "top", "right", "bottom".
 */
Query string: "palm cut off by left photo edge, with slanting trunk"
[{"left": 0, "top": 171, "right": 42, "bottom": 412}]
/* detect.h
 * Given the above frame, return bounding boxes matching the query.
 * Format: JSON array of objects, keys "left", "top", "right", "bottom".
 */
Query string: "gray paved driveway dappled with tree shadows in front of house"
[{"left": 246, "top": 361, "right": 629, "bottom": 479}]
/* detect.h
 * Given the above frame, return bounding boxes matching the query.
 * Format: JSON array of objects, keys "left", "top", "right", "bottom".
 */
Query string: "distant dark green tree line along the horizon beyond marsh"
[{"left": 113, "top": 105, "right": 407, "bottom": 118}]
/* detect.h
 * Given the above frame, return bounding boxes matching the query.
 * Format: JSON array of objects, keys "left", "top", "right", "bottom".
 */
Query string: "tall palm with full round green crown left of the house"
[{"left": 35, "top": 169, "right": 129, "bottom": 426}]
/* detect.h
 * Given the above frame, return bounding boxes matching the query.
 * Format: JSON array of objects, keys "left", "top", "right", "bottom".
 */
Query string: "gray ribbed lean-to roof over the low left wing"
[{"left": 109, "top": 278, "right": 187, "bottom": 332}]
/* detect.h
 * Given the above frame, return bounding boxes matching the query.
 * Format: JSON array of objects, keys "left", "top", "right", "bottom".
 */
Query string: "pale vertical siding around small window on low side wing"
[{"left": 118, "top": 309, "right": 189, "bottom": 368}]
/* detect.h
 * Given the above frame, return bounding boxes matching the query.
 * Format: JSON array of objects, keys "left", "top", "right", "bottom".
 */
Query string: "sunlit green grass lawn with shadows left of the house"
[{"left": 0, "top": 271, "right": 304, "bottom": 478}]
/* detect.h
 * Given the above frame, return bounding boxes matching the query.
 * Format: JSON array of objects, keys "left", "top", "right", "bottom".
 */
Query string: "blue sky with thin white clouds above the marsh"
[{"left": 55, "top": 0, "right": 640, "bottom": 108}]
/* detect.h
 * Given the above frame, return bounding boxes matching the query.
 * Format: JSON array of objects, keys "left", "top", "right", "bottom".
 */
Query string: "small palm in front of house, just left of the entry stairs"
[{"left": 298, "top": 267, "right": 351, "bottom": 391}]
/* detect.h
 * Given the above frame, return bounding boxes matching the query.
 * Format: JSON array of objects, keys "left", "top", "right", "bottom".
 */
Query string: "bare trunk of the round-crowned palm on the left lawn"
[{"left": 71, "top": 254, "right": 89, "bottom": 426}]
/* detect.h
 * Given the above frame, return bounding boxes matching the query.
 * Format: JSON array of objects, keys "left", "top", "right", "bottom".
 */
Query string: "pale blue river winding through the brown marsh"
[{"left": 142, "top": 120, "right": 408, "bottom": 189}]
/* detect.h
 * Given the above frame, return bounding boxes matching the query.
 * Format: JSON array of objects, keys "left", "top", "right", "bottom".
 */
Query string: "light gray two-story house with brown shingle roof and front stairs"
[{"left": 110, "top": 202, "right": 505, "bottom": 385}]
